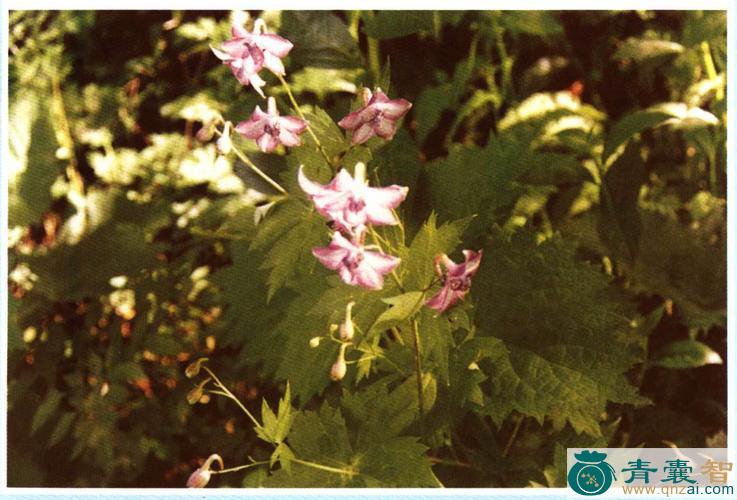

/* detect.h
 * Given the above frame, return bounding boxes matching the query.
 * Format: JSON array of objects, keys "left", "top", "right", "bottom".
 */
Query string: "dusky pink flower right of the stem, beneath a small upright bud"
[{"left": 338, "top": 88, "right": 412, "bottom": 144}]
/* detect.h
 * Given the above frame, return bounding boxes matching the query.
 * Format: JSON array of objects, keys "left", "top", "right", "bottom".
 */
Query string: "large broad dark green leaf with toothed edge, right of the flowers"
[{"left": 471, "top": 230, "right": 645, "bottom": 435}]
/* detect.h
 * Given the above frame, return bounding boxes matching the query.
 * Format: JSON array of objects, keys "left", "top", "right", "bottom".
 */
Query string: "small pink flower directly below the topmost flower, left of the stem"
[{"left": 235, "top": 97, "right": 307, "bottom": 153}]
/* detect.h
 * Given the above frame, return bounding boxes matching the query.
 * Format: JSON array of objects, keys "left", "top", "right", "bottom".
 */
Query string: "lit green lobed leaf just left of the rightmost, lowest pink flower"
[{"left": 400, "top": 214, "right": 470, "bottom": 290}]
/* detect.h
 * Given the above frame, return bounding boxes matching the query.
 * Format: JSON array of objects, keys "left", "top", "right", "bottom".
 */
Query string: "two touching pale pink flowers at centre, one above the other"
[{"left": 298, "top": 163, "right": 408, "bottom": 290}]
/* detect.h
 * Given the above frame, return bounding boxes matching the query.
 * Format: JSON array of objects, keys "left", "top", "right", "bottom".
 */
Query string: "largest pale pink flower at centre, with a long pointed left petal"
[{"left": 298, "top": 162, "right": 408, "bottom": 231}]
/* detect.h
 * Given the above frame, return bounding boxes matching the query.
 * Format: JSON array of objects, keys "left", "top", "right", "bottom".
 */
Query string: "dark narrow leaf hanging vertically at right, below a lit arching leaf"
[{"left": 599, "top": 145, "right": 646, "bottom": 262}]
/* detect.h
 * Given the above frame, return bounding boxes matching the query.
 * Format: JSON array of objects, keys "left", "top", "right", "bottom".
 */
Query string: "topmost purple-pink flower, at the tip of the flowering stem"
[{"left": 210, "top": 19, "right": 293, "bottom": 97}]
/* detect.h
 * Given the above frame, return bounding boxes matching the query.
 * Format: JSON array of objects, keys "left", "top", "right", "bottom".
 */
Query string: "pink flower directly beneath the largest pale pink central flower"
[{"left": 312, "top": 231, "right": 400, "bottom": 290}]
